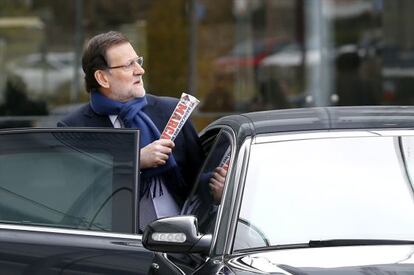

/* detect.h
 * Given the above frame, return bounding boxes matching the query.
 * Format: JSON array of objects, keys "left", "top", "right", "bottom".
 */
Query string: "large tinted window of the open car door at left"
[{"left": 0, "top": 130, "right": 137, "bottom": 233}]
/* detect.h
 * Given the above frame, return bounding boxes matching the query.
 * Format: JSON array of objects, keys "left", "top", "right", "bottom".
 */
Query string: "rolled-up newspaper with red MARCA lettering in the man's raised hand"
[{"left": 161, "top": 93, "right": 200, "bottom": 141}]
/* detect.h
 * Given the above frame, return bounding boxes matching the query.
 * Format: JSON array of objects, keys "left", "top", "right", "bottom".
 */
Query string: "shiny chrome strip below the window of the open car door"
[{"left": 0, "top": 224, "right": 142, "bottom": 240}]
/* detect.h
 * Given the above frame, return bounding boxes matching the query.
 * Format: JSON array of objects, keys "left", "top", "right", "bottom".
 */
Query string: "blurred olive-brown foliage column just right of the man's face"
[{"left": 145, "top": 0, "right": 188, "bottom": 96}]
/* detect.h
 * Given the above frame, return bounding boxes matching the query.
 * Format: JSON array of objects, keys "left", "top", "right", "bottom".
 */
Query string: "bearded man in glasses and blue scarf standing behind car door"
[{"left": 58, "top": 31, "right": 204, "bottom": 229}]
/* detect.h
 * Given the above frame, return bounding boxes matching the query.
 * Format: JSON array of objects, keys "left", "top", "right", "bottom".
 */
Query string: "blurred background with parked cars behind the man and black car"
[{"left": 0, "top": 0, "right": 414, "bottom": 130}]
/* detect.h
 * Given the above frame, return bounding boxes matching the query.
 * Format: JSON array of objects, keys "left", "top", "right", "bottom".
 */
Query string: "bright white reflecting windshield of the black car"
[{"left": 235, "top": 136, "right": 414, "bottom": 250}]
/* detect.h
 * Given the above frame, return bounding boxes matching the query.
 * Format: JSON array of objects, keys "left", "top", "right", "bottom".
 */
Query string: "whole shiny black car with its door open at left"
[{"left": 0, "top": 107, "right": 414, "bottom": 274}]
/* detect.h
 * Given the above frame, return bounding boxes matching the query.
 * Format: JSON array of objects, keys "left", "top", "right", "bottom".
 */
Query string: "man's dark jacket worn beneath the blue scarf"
[{"left": 57, "top": 94, "right": 204, "bottom": 203}]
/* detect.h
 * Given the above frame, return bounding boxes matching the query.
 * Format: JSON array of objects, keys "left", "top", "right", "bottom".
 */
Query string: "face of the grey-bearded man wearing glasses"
[{"left": 105, "top": 43, "right": 145, "bottom": 102}]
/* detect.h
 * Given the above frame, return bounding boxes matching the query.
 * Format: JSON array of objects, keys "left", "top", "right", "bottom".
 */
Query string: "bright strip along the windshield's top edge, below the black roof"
[{"left": 254, "top": 129, "right": 414, "bottom": 144}]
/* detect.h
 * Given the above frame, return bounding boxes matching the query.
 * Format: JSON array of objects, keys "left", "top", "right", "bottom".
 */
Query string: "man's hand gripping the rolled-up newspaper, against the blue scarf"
[{"left": 139, "top": 139, "right": 175, "bottom": 169}]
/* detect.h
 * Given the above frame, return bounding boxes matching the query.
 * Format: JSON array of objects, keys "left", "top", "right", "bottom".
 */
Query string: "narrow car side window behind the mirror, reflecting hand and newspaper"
[{"left": 183, "top": 131, "right": 231, "bottom": 233}]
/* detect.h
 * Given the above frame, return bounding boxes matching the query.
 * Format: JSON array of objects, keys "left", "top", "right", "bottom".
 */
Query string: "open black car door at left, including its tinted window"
[{"left": 0, "top": 128, "right": 154, "bottom": 274}]
